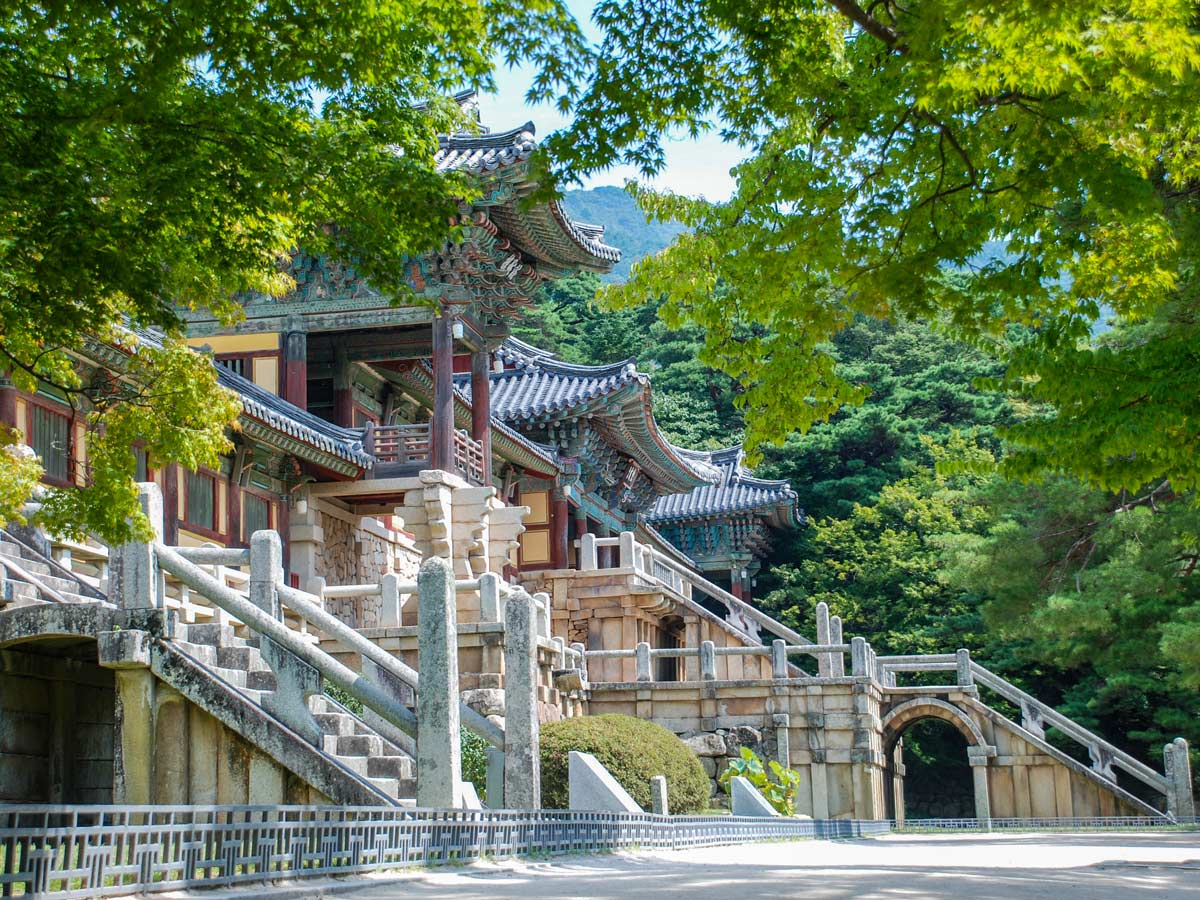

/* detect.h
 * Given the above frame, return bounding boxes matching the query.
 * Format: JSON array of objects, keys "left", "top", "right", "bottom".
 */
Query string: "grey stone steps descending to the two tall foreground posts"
[{"left": 164, "top": 623, "right": 416, "bottom": 805}]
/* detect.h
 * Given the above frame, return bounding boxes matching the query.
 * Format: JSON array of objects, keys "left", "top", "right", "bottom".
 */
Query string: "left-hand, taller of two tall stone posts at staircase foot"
[{"left": 416, "top": 557, "right": 462, "bottom": 809}]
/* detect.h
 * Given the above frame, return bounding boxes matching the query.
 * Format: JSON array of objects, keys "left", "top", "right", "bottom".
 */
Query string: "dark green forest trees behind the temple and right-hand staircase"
[{"left": 516, "top": 192, "right": 1200, "bottom": 811}]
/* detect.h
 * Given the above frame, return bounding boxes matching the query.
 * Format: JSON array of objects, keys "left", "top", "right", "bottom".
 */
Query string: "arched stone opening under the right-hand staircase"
[{"left": 882, "top": 697, "right": 992, "bottom": 821}]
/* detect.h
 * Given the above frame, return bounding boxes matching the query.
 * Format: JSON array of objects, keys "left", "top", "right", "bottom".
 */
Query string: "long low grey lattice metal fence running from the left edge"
[{"left": 0, "top": 805, "right": 890, "bottom": 900}]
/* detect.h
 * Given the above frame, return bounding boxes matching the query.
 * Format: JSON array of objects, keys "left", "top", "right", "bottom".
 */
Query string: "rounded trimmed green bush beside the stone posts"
[{"left": 541, "top": 715, "right": 709, "bottom": 815}]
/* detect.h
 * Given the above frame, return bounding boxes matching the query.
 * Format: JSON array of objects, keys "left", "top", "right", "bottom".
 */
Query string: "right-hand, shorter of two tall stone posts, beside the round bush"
[{"left": 501, "top": 590, "right": 541, "bottom": 809}]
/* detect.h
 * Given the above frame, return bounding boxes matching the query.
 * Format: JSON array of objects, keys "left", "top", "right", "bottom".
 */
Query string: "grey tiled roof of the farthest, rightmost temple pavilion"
[{"left": 646, "top": 446, "right": 797, "bottom": 526}]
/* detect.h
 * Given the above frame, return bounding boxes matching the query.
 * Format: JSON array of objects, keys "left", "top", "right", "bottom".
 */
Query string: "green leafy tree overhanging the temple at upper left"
[{"left": 0, "top": 0, "right": 584, "bottom": 540}]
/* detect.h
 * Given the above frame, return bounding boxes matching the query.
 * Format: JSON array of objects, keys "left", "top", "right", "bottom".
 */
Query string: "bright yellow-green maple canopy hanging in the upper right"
[{"left": 553, "top": 0, "right": 1200, "bottom": 490}]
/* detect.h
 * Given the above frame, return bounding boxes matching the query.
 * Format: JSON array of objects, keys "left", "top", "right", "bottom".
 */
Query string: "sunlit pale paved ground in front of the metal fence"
[{"left": 236, "top": 833, "right": 1200, "bottom": 900}]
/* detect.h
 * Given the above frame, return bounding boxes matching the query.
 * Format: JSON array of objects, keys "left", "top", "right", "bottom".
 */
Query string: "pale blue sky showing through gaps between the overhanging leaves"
[{"left": 468, "top": 0, "right": 742, "bottom": 200}]
